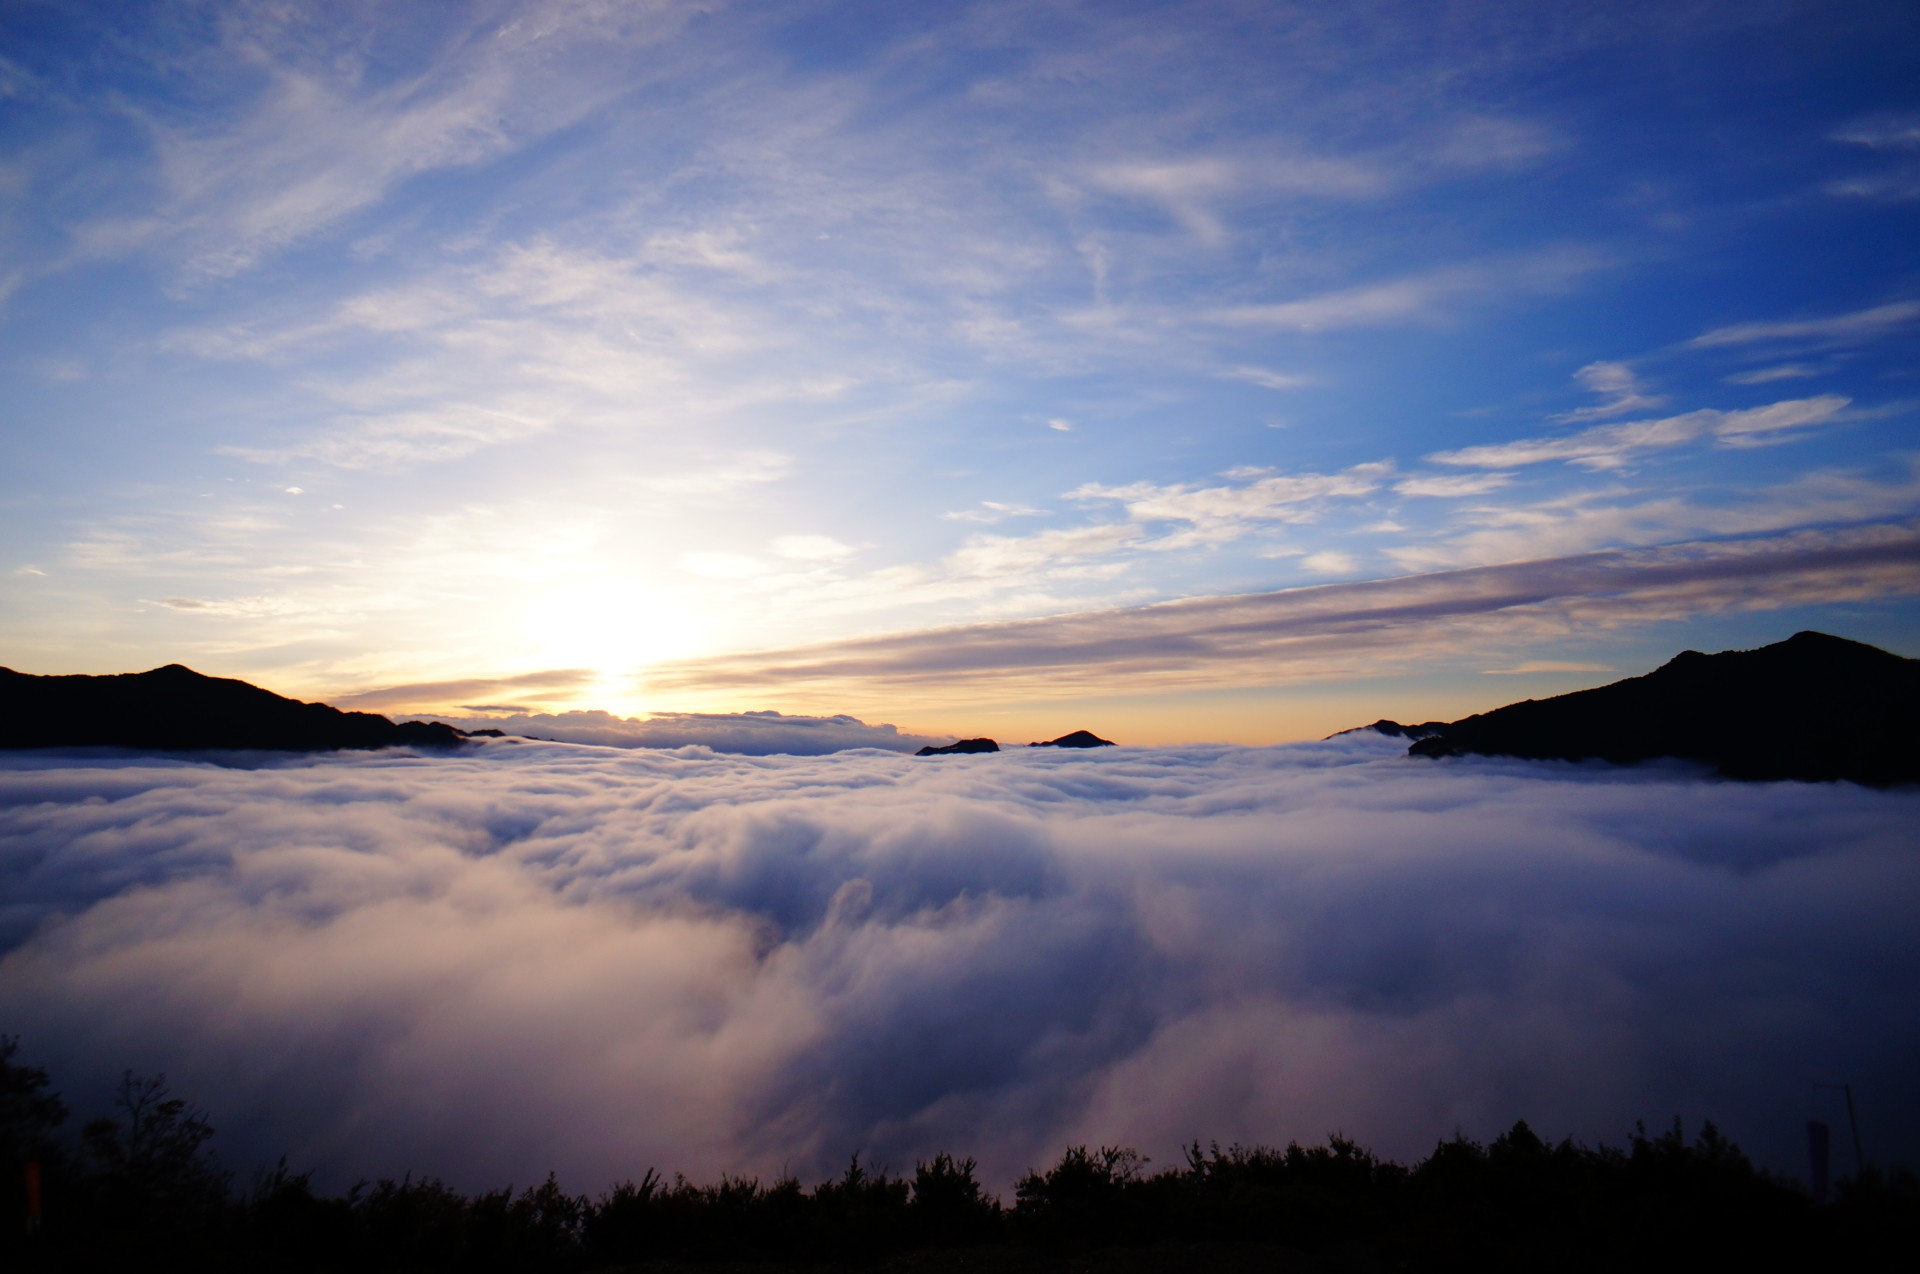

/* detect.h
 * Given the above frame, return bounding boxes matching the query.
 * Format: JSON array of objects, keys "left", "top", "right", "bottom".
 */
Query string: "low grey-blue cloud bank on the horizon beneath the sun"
[{"left": 412, "top": 704, "right": 952, "bottom": 756}]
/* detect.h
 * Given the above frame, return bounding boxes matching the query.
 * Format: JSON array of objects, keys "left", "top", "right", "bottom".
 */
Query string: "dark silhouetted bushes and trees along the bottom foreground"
[{"left": 0, "top": 1036, "right": 1920, "bottom": 1272}]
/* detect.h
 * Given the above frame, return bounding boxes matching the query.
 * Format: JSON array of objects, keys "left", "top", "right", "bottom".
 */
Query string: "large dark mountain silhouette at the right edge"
[{"left": 1409, "top": 633, "right": 1920, "bottom": 787}]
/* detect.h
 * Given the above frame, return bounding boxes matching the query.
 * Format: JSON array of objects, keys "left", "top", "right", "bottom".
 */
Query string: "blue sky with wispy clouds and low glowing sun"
[{"left": 0, "top": 0, "right": 1920, "bottom": 743}]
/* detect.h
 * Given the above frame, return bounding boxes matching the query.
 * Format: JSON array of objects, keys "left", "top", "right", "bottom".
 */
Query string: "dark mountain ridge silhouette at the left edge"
[{"left": 0, "top": 664, "right": 465, "bottom": 752}]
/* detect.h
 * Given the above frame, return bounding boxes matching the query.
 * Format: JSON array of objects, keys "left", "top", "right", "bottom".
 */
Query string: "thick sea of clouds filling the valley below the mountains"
[{"left": 0, "top": 733, "right": 1920, "bottom": 1191}]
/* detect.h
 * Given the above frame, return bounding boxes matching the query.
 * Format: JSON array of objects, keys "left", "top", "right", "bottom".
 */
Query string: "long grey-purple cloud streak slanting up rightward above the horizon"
[{"left": 649, "top": 522, "right": 1920, "bottom": 702}]
